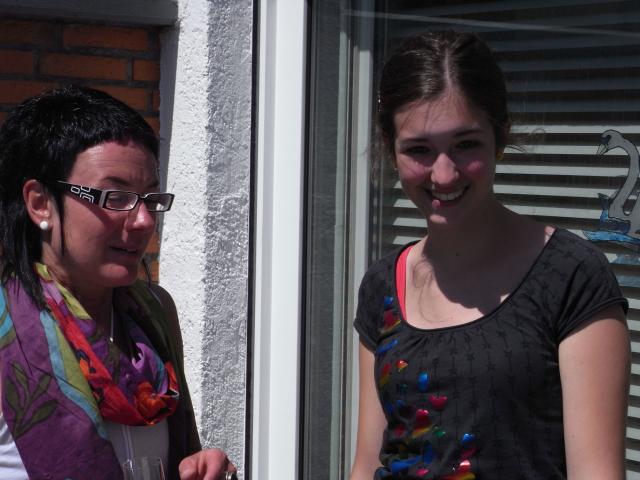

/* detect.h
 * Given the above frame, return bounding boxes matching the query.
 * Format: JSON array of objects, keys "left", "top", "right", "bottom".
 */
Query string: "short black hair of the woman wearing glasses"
[{"left": 0, "top": 85, "right": 158, "bottom": 306}]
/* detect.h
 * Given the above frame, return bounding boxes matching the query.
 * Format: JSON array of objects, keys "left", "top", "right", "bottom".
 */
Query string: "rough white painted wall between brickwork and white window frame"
[{"left": 160, "top": 0, "right": 253, "bottom": 477}]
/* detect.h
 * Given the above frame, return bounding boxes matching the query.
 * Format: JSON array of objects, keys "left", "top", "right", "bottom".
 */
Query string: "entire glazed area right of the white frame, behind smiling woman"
[{"left": 300, "top": 0, "right": 640, "bottom": 479}]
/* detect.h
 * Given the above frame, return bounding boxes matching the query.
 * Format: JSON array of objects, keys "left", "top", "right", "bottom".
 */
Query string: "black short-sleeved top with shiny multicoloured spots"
[{"left": 354, "top": 230, "right": 627, "bottom": 480}]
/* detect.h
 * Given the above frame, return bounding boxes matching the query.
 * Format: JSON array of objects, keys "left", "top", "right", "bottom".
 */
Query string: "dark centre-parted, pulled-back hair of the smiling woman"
[{"left": 377, "top": 30, "right": 511, "bottom": 159}]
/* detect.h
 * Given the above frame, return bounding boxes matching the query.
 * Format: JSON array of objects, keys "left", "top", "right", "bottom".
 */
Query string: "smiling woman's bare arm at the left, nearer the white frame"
[{"left": 351, "top": 344, "right": 387, "bottom": 480}]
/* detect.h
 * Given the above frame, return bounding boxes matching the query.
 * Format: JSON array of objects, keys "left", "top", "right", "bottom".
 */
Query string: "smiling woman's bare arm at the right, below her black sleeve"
[{"left": 559, "top": 306, "right": 631, "bottom": 480}]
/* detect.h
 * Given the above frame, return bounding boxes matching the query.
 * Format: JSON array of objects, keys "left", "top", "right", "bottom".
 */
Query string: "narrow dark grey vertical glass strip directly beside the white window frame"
[{"left": 301, "top": 1, "right": 351, "bottom": 480}]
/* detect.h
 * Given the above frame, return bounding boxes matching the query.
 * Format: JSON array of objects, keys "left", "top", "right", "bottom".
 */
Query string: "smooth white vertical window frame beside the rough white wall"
[{"left": 250, "top": 0, "right": 307, "bottom": 480}]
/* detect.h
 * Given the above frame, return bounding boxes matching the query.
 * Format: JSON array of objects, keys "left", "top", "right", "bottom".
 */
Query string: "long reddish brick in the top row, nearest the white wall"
[{"left": 62, "top": 25, "right": 149, "bottom": 51}]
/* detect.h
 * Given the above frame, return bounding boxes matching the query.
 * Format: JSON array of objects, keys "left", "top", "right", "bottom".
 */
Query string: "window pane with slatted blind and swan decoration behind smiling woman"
[{"left": 371, "top": 0, "right": 640, "bottom": 478}]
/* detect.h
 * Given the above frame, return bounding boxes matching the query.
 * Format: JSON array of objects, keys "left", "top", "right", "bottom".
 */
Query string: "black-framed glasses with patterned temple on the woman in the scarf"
[{"left": 58, "top": 180, "right": 174, "bottom": 213}]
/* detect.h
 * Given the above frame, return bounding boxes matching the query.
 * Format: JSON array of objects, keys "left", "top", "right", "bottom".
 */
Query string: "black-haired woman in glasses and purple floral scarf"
[{"left": 0, "top": 87, "right": 235, "bottom": 480}]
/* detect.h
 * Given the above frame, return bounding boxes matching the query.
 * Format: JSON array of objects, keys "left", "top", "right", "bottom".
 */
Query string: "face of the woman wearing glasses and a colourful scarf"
[{"left": 42, "top": 141, "right": 159, "bottom": 293}]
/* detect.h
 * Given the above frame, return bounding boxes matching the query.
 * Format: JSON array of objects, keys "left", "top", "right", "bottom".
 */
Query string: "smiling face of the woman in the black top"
[{"left": 394, "top": 91, "right": 496, "bottom": 232}]
